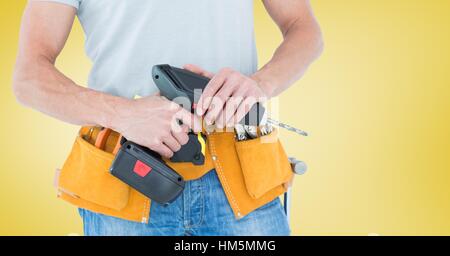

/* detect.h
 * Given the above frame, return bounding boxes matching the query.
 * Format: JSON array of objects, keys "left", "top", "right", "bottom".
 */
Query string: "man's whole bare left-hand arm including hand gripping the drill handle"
[{"left": 13, "top": 0, "right": 199, "bottom": 157}]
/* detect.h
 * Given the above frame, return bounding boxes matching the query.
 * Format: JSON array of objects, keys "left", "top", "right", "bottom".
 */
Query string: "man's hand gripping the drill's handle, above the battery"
[{"left": 111, "top": 95, "right": 201, "bottom": 158}]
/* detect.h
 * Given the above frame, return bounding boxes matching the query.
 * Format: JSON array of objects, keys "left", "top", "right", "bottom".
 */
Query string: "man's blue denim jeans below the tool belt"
[{"left": 79, "top": 170, "right": 290, "bottom": 236}]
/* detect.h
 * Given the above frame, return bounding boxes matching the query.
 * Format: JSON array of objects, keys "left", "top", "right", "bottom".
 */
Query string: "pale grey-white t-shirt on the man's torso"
[{"left": 45, "top": 0, "right": 257, "bottom": 98}]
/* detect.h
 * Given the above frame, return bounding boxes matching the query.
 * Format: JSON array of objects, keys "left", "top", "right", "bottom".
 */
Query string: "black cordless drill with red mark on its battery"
[{"left": 110, "top": 65, "right": 264, "bottom": 204}]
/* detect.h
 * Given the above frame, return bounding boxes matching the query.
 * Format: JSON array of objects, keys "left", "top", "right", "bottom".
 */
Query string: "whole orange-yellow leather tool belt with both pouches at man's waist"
[{"left": 57, "top": 127, "right": 293, "bottom": 222}]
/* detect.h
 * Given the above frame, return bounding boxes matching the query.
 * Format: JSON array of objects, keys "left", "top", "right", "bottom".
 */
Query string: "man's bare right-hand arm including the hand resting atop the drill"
[{"left": 185, "top": 0, "right": 323, "bottom": 128}]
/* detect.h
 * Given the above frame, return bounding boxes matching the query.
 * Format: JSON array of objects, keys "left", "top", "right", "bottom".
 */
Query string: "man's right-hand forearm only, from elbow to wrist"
[{"left": 252, "top": 12, "right": 323, "bottom": 97}]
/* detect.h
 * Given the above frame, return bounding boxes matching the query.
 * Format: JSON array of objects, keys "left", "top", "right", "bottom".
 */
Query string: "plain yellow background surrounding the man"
[{"left": 0, "top": 0, "right": 450, "bottom": 235}]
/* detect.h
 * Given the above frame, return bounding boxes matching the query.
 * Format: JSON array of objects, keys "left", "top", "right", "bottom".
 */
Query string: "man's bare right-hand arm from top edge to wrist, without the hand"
[{"left": 253, "top": 0, "right": 323, "bottom": 97}]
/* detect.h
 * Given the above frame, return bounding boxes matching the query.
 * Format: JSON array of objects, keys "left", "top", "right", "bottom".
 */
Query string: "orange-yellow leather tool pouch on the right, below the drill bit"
[{"left": 208, "top": 130, "right": 293, "bottom": 218}]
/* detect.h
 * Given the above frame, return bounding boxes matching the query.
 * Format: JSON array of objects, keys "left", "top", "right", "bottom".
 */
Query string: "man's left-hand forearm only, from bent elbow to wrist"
[{"left": 14, "top": 57, "right": 126, "bottom": 128}]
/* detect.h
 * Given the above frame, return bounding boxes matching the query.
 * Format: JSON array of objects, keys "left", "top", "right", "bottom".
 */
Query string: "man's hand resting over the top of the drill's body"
[{"left": 184, "top": 64, "right": 268, "bottom": 129}]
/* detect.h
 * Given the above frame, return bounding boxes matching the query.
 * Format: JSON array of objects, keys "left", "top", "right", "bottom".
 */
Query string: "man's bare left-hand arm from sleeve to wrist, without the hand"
[{"left": 14, "top": 1, "right": 125, "bottom": 127}]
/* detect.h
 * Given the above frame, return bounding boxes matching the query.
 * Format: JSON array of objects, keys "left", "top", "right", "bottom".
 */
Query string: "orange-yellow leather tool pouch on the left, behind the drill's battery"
[{"left": 56, "top": 127, "right": 150, "bottom": 223}]
